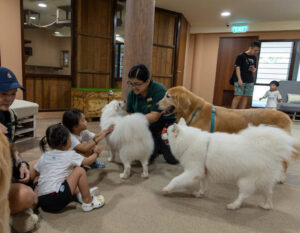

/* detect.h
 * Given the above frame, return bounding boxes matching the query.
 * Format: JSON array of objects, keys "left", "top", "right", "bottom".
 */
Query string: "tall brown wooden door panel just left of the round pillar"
[{"left": 75, "top": 0, "right": 114, "bottom": 88}]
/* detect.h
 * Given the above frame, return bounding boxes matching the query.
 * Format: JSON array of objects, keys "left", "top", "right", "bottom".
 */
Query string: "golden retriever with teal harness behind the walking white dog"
[{"left": 158, "top": 86, "right": 291, "bottom": 182}]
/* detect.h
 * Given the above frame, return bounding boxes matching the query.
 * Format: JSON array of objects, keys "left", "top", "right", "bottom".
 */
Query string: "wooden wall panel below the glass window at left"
[{"left": 25, "top": 74, "right": 71, "bottom": 110}]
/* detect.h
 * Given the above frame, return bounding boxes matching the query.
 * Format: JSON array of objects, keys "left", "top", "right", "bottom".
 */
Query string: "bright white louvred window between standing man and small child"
[{"left": 252, "top": 41, "right": 295, "bottom": 107}]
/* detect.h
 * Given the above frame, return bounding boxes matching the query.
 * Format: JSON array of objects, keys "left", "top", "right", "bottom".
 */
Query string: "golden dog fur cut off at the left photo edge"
[{"left": 0, "top": 132, "right": 12, "bottom": 233}]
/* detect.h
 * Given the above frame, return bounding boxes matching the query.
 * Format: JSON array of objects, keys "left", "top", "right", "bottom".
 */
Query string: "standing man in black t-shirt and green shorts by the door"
[{"left": 231, "top": 42, "right": 260, "bottom": 109}]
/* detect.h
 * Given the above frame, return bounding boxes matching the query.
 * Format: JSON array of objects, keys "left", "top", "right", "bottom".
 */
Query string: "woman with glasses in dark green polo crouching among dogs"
[{"left": 127, "top": 65, "right": 178, "bottom": 164}]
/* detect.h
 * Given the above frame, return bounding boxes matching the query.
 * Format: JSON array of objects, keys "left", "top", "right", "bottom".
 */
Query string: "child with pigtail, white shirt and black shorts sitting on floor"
[{"left": 34, "top": 124, "right": 108, "bottom": 212}]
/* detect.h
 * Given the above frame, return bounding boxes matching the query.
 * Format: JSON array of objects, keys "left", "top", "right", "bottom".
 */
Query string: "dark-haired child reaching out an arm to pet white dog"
[{"left": 62, "top": 109, "right": 112, "bottom": 168}]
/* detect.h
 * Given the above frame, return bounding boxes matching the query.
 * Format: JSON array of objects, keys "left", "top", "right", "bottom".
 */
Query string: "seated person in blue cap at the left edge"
[{"left": 0, "top": 67, "right": 38, "bottom": 232}]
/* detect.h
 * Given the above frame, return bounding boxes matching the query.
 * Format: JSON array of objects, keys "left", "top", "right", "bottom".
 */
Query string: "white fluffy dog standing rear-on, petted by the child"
[{"left": 100, "top": 100, "right": 154, "bottom": 179}]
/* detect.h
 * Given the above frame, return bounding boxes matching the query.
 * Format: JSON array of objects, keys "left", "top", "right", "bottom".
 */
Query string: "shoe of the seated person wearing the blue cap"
[{"left": 11, "top": 209, "right": 39, "bottom": 233}]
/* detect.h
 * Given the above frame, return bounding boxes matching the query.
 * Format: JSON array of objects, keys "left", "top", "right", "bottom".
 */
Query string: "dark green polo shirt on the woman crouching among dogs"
[{"left": 126, "top": 81, "right": 176, "bottom": 128}]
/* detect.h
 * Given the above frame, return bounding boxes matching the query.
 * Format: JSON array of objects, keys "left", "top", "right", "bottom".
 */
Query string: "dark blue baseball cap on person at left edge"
[{"left": 0, "top": 66, "right": 25, "bottom": 92}]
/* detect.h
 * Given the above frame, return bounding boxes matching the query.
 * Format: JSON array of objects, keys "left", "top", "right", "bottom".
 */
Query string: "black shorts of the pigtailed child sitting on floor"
[{"left": 39, "top": 180, "right": 74, "bottom": 212}]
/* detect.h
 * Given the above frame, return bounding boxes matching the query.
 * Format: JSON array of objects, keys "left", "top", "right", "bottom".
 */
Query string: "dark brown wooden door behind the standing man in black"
[{"left": 213, "top": 36, "right": 258, "bottom": 107}]
